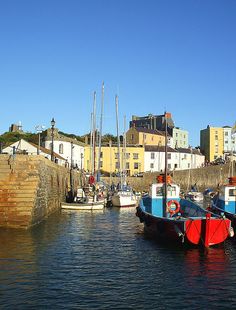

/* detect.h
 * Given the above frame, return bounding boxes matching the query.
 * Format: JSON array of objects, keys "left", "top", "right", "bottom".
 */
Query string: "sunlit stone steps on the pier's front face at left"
[{"left": 0, "top": 157, "right": 39, "bottom": 227}]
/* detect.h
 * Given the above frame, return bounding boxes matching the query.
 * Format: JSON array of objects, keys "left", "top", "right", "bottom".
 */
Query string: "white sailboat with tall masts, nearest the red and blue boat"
[{"left": 111, "top": 96, "right": 137, "bottom": 207}]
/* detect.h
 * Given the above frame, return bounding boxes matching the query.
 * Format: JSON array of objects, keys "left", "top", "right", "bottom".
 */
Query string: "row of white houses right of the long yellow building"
[{"left": 144, "top": 145, "right": 205, "bottom": 172}]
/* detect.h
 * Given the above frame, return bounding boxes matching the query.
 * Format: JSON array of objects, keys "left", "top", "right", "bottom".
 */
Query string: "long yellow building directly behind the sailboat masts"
[{"left": 84, "top": 145, "right": 144, "bottom": 176}]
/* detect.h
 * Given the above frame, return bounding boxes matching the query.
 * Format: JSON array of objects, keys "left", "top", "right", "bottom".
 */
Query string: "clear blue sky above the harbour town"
[{"left": 0, "top": 0, "right": 236, "bottom": 146}]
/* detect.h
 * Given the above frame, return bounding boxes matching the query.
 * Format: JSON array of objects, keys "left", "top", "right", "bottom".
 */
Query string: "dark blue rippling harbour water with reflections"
[{"left": 0, "top": 208, "right": 236, "bottom": 309}]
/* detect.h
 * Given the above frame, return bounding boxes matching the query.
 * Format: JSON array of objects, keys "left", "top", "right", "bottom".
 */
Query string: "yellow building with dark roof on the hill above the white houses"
[{"left": 126, "top": 127, "right": 165, "bottom": 146}]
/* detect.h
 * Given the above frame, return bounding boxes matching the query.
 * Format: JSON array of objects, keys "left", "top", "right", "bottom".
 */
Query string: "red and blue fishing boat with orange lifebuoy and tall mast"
[{"left": 136, "top": 114, "right": 233, "bottom": 247}]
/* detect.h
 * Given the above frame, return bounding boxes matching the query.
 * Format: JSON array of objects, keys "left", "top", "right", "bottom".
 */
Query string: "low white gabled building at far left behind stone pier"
[{"left": 2, "top": 139, "right": 66, "bottom": 166}]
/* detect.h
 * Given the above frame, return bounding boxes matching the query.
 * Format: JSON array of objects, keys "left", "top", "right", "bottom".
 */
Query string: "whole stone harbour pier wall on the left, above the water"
[{"left": 0, "top": 155, "right": 80, "bottom": 229}]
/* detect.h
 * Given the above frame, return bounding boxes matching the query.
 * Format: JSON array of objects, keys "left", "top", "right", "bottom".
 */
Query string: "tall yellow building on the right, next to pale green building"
[{"left": 200, "top": 125, "right": 224, "bottom": 162}]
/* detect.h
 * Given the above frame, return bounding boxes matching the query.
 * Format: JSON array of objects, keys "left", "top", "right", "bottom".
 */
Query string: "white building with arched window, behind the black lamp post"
[{"left": 44, "top": 128, "right": 85, "bottom": 169}]
